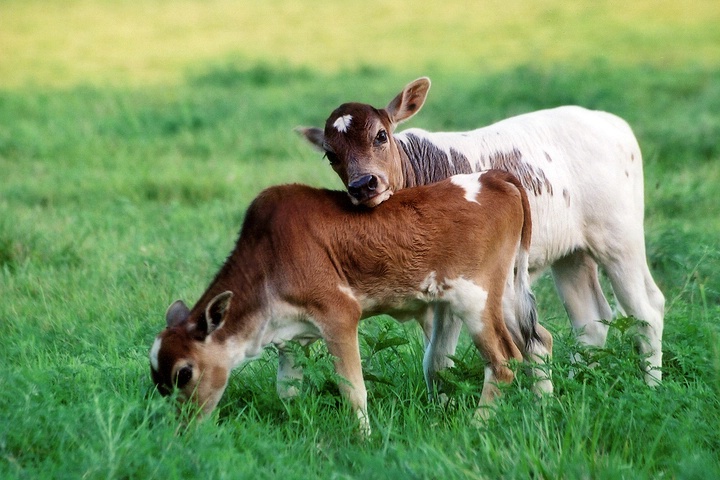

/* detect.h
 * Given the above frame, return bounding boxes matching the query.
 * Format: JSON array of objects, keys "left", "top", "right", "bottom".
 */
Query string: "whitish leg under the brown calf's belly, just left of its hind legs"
[{"left": 423, "top": 303, "right": 462, "bottom": 399}]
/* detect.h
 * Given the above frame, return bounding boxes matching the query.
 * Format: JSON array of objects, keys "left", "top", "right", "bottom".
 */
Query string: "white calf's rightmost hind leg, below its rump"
[{"left": 603, "top": 249, "right": 665, "bottom": 386}]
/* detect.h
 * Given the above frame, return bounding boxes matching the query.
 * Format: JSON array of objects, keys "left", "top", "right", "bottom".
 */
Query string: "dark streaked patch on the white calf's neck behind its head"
[{"left": 398, "top": 134, "right": 473, "bottom": 187}]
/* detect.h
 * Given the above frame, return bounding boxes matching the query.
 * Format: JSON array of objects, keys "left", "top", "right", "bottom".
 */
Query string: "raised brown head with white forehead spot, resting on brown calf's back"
[{"left": 298, "top": 77, "right": 430, "bottom": 207}]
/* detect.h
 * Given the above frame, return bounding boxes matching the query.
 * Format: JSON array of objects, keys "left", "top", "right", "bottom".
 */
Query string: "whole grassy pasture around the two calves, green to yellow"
[{"left": 0, "top": 0, "right": 720, "bottom": 479}]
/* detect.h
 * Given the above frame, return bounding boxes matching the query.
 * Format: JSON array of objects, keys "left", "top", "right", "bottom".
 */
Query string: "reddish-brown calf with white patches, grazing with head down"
[{"left": 150, "top": 171, "right": 552, "bottom": 431}]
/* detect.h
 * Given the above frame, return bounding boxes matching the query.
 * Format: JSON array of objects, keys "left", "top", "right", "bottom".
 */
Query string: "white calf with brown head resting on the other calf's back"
[{"left": 298, "top": 78, "right": 665, "bottom": 385}]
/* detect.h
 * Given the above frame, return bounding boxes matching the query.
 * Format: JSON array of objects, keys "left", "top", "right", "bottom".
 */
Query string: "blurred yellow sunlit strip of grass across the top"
[{"left": 0, "top": 0, "right": 720, "bottom": 87}]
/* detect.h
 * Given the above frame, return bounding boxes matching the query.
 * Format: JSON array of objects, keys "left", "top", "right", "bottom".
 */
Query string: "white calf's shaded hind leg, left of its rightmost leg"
[{"left": 552, "top": 250, "right": 612, "bottom": 347}]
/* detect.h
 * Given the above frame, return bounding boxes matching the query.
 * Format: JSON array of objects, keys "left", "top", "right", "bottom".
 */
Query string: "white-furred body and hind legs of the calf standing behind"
[{"left": 396, "top": 106, "right": 665, "bottom": 384}]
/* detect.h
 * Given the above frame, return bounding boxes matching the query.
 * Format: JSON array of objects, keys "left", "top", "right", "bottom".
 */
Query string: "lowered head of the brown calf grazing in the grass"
[{"left": 150, "top": 292, "right": 232, "bottom": 415}]
